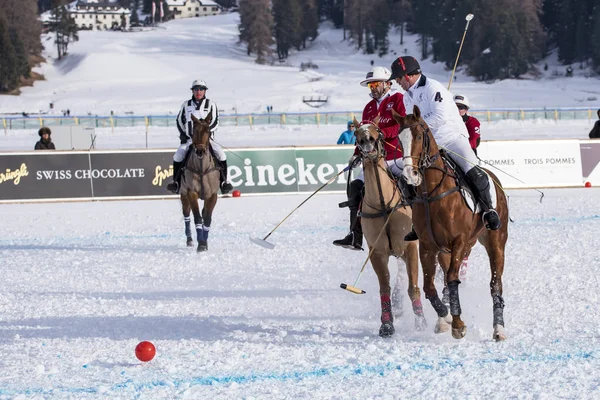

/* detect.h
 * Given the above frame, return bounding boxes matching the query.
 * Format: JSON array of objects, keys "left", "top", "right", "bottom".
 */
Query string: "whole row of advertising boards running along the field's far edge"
[{"left": 0, "top": 140, "right": 588, "bottom": 202}]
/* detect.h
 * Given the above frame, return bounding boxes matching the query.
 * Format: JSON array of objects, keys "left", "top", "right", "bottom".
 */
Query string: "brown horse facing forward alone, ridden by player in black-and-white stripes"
[{"left": 179, "top": 114, "right": 220, "bottom": 252}]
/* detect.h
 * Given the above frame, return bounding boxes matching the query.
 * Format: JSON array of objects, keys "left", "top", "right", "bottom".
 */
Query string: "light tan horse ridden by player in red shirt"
[{"left": 354, "top": 119, "right": 427, "bottom": 337}]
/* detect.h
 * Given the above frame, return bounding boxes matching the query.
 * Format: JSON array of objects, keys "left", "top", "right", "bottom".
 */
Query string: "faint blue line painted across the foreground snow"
[{"left": 0, "top": 351, "right": 598, "bottom": 396}]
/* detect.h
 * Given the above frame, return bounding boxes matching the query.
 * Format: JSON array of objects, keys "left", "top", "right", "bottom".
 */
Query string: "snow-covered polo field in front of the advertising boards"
[{"left": 0, "top": 189, "right": 600, "bottom": 399}]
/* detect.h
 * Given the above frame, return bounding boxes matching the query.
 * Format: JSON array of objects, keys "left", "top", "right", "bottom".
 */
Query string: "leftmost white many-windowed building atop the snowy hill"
[{"left": 69, "top": 0, "right": 131, "bottom": 31}]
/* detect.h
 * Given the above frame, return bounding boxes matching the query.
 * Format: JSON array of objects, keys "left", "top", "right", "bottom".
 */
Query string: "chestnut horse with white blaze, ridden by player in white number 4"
[{"left": 394, "top": 106, "right": 508, "bottom": 341}]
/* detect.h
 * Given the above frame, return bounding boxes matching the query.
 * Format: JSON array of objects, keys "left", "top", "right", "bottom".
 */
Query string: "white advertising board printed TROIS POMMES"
[{"left": 477, "top": 140, "right": 582, "bottom": 189}]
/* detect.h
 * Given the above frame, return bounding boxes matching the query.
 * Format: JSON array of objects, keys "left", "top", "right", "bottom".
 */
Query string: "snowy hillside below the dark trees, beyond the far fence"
[{"left": 0, "top": 14, "right": 600, "bottom": 115}]
